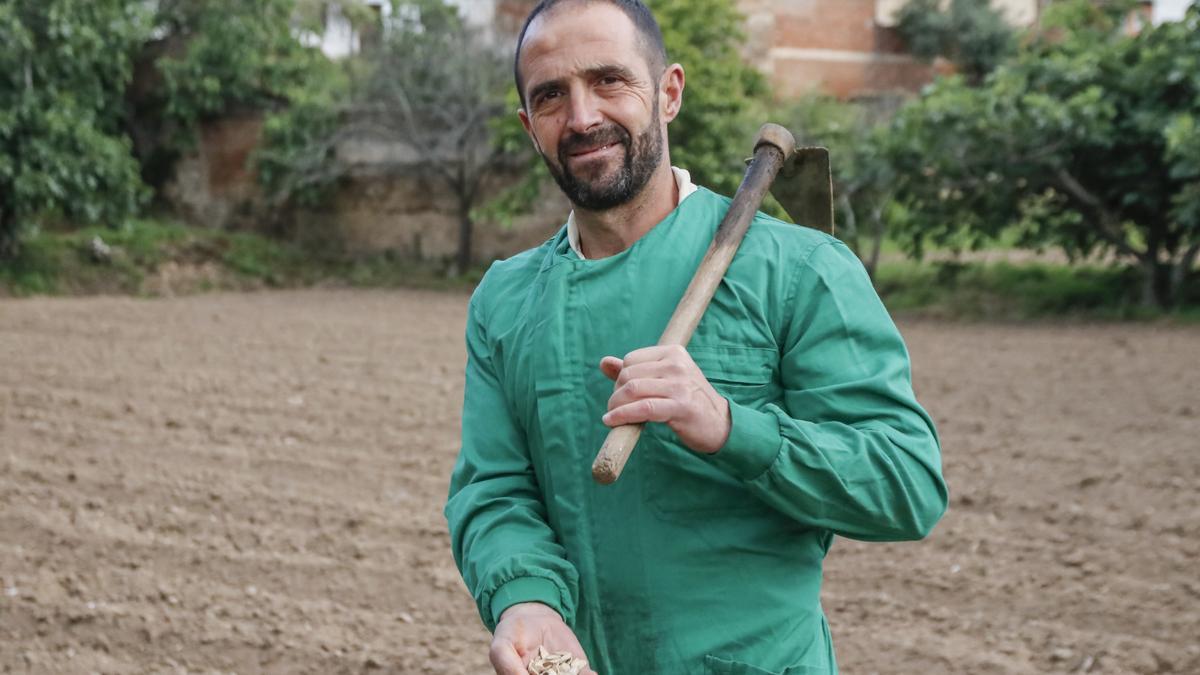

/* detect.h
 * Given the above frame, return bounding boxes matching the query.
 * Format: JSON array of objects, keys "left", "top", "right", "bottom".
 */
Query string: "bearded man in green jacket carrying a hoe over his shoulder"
[{"left": 445, "top": 0, "right": 947, "bottom": 675}]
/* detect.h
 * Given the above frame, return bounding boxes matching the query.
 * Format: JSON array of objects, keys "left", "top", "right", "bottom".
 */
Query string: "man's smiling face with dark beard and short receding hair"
[{"left": 520, "top": 2, "right": 674, "bottom": 210}]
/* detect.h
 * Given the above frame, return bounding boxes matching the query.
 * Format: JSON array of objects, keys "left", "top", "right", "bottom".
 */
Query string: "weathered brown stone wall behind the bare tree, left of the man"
[{"left": 164, "top": 115, "right": 570, "bottom": 261}]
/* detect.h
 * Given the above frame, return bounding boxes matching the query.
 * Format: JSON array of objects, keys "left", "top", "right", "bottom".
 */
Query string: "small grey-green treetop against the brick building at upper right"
[{"left": 896, "top": 0, "right": 1016, "bottom": 84}]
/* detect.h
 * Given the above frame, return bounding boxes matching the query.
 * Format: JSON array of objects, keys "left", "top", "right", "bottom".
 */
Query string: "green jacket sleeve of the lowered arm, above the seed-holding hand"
[{"left": 445, "top": 294, "right": 578, "bottom": 631}]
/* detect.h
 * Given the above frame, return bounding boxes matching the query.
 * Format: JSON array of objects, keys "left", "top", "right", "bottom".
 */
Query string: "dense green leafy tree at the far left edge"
[{"left": 0, "top": 0, "right": 144, "bottom": 257}]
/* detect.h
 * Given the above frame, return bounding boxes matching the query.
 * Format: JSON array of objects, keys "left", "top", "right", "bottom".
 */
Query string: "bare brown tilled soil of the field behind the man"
[{"left": 0, "top": 291, "right": 1200, "bottom": 675}]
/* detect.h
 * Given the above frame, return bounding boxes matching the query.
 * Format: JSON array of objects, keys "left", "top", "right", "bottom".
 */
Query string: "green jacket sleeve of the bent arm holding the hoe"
[{"left": 709, "top": 241, "right": 947, "bottom": 542}]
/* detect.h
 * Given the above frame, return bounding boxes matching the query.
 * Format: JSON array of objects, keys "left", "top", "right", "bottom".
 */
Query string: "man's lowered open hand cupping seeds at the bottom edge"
[{"left": 488, "top": 603, "right": 595, "bottom": 675}]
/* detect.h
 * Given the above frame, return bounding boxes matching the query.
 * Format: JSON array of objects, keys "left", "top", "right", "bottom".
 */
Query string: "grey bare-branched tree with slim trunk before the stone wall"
[{"left": 259, "top": 0, "right": 511, "bottom": 274}]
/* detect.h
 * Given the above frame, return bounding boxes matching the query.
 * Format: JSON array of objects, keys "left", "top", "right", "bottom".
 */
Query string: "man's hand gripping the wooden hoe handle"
[{"left": 600, "top": 347, "right": 731, "bottom": 454}]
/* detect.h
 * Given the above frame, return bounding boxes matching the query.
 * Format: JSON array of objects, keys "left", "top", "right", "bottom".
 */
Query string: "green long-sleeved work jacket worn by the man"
[{"left": 445, "top": 189, "right": 947, "bottom": 675}]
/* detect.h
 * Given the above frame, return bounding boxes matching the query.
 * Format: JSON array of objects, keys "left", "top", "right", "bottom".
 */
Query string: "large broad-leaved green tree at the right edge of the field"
[{"left": 887, "top": 0, "right": 1200, "bottom": 307}]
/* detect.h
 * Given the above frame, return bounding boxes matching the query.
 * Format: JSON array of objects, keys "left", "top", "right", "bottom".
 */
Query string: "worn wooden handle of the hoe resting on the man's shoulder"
[{"left": 592, "top": 124, "right": 796, "bottom": 485}]
